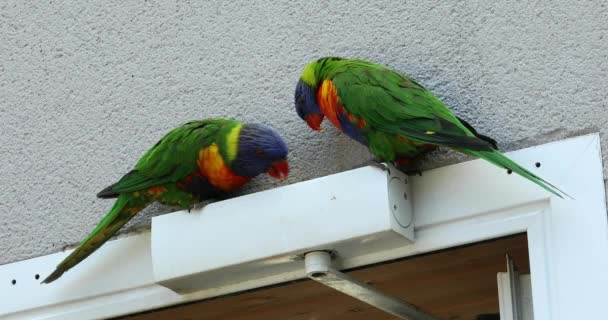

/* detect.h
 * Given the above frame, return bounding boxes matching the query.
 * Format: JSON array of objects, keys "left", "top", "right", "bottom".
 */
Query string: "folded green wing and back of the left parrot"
[{"left": 97, "top": 119, "right": 236, "bottom": 198}]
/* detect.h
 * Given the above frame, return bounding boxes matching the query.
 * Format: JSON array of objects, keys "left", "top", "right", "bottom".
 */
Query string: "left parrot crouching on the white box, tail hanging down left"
[{"left": 42, "top": 119, "right": 289, "bottom": 283}]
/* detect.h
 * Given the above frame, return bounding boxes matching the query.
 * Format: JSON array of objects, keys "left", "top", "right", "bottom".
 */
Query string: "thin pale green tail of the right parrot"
[{"left": 466, "top": 149, "right": 574, "bottom": 200}]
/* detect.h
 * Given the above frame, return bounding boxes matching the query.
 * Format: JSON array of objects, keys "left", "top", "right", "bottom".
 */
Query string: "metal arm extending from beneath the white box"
[{"left": 304, "top": 251, "right": 437, "bottom": 320}]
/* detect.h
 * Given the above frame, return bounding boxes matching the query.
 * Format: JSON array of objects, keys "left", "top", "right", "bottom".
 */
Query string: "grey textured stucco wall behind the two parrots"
[{"left": 0, "top": 0, "right": 608, "bottom": 264}]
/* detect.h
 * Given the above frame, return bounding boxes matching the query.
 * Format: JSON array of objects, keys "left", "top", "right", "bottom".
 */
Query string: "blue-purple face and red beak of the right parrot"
[{"left": 295, "top": 78, "right": 324, "bottom": 131}]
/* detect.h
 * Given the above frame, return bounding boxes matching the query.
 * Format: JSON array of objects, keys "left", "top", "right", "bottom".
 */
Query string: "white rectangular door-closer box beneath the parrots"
[{"left": 152, "top": 165, "right": 414, "bottom": 294}]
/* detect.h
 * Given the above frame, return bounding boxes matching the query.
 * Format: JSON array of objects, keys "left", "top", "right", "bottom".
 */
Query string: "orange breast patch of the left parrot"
[{"left": 197, "top": 144, "right": 251, "bottom": 191}]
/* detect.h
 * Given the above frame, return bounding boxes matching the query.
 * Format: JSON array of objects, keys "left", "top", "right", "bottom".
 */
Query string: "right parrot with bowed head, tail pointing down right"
[{"left": 295, "top": 57, "right": 566, "bottom": 198}]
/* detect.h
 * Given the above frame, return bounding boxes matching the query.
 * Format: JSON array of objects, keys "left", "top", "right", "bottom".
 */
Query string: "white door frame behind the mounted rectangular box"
[{"left": 0, "top": 134, "right": 608, "bottom": 320}]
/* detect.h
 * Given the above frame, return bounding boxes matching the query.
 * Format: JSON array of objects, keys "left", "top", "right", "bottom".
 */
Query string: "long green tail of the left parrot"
[{"left": 42, "top": 194, "right": 147, "bottom": 283}]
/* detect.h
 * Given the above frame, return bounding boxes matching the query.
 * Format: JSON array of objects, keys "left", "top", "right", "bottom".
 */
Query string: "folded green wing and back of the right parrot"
[{"left": 326, "top": 60, "right": 492, "bottom": 151}]
